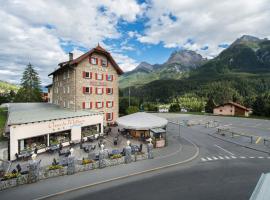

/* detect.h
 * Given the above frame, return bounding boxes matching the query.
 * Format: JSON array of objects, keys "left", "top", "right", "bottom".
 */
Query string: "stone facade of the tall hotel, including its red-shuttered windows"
[{"left": 52, "top": 46, "right": 122, "bottom": 123}]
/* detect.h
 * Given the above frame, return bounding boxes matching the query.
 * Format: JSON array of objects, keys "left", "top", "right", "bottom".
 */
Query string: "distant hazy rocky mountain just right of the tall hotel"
[{"left": 119, "top": 50, "right": 206, "bottom": 88}]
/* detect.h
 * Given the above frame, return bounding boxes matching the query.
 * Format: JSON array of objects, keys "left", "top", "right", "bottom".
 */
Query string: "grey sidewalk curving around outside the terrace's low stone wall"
[{"left": 0, "top": 136, "right": 199, "bottom": 200}]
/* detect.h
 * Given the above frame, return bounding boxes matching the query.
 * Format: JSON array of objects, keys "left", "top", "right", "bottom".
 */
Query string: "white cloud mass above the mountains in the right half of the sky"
[{"left": 138, "top": 0, "right": 270, "bottom": 57}]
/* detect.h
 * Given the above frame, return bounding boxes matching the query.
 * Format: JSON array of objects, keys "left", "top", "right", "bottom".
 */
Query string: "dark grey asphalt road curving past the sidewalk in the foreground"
[{"left": 47, "top": 119, "right": 270, "bottom": 200}]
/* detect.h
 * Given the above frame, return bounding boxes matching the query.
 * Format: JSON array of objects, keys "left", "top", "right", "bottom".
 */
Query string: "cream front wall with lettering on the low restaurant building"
[{"left": 10, "top": 114, "right": 103, "bottom": 160}]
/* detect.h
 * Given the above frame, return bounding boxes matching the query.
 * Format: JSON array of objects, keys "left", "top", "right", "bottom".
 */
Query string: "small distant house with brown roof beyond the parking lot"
[{"left": 213, "top": 101, "right": 251, "bottom": 117}]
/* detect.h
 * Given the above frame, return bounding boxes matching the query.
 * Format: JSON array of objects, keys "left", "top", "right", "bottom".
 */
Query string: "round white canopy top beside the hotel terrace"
[{"left": 116, "top": 112, "right": 168, "bottom": 130}]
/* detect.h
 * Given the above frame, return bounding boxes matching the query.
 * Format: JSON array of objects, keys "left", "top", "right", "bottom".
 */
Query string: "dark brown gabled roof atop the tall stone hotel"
[{"left": 48, "top": 44, "right": 124, "bottom": 76}]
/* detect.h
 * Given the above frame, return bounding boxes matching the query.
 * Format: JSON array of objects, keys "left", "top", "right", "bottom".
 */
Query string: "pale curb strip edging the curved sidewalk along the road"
[{"left": 33, "top": 138, "right": 200, "bottom": 200}]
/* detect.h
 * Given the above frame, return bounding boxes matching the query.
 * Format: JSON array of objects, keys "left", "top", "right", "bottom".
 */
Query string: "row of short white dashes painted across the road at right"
[{"left": 201, "top": 155, "right": 270, "bottom": 162}]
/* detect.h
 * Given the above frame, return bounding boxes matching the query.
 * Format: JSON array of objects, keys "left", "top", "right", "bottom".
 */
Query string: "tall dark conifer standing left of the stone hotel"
[{"left": 14, "top": 63, "right": 42, "bottom": 102}]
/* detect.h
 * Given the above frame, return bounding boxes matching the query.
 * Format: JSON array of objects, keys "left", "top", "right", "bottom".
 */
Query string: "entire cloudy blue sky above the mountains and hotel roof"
[{"left": 0, "top": 0, "right": 270, "bottom": 85}]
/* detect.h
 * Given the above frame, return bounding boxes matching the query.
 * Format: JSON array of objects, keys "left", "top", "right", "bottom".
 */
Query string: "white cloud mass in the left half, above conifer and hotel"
[{"left": 0, "top": 0, "right": 143, "bottom": 84}]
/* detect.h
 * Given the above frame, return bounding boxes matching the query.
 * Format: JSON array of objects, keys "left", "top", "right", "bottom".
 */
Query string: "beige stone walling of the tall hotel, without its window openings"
[{"left": 53, "top": 53, "right": 119, "bottom": 123}]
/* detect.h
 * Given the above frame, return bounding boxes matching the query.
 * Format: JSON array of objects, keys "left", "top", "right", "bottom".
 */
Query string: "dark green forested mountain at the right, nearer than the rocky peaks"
[{"left": 122, "top": 35, "right": 270, "bottom": 106}]
